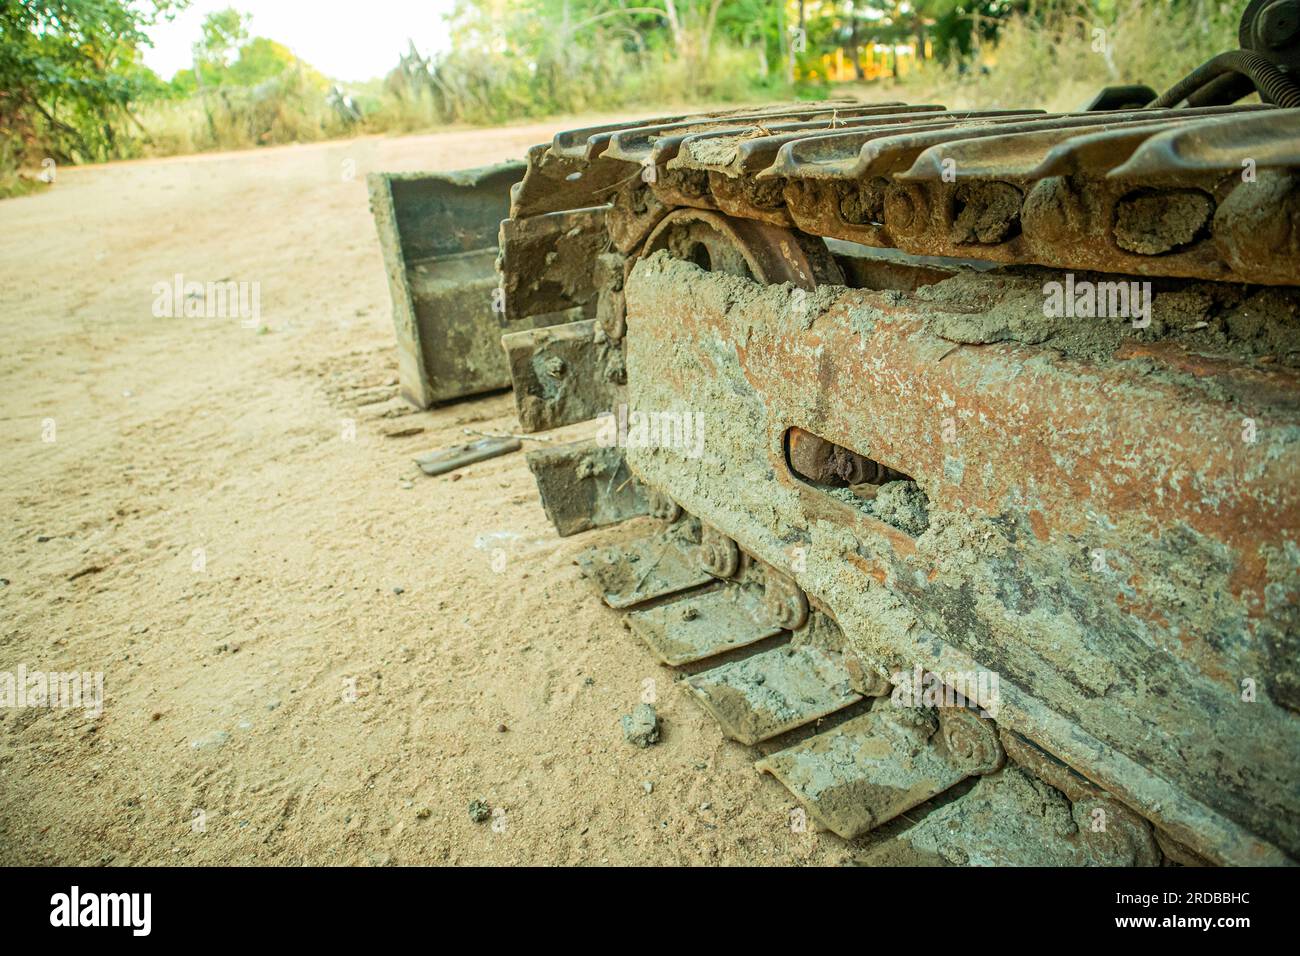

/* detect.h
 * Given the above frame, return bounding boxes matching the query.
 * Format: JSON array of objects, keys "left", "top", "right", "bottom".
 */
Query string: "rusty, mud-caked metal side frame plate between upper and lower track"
[{"left": 627, "top": 254, "right": 1300, "bottom": 864}]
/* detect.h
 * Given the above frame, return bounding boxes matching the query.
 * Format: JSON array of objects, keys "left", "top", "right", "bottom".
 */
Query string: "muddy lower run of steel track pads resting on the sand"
[{"left": 579, "top": 514, "right": 1159, "bottom": 866}]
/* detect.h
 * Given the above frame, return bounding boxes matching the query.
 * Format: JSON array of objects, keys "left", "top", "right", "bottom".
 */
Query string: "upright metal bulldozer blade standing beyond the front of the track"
[{"left": 368, "top": 163, "right": 524, "bottom": 408}]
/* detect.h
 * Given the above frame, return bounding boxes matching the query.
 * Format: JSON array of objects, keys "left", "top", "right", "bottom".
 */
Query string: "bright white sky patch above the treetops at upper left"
[{"left": 144, "top": 0, "right": 452, "bottom": 81}]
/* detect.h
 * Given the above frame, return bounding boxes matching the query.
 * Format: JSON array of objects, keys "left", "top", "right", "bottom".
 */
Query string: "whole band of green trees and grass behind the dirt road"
[{"left": 0, "top": 0, "right": 1242, "bottom": 188}]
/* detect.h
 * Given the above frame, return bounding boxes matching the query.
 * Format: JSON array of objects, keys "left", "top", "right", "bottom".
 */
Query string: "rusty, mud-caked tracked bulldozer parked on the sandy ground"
[{"left": 369, "top": 0, "right": 1300, "bottom": 866}]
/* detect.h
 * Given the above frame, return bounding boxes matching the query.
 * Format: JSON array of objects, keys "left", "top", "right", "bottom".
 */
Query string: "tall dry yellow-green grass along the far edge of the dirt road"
[{"left": 0, "top": 0, "right": 1239, "bottom": 187}]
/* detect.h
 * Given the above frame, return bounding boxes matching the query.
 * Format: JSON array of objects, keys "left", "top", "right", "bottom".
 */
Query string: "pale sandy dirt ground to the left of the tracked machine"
[{"left": 0, "top": 121, "right": 849, "bottom": 865}]
